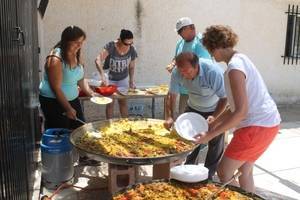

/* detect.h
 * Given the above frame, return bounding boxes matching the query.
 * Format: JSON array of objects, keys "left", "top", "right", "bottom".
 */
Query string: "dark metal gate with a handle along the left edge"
[{"left": 0, "top": 0, "right": 39, "bottom": 200}]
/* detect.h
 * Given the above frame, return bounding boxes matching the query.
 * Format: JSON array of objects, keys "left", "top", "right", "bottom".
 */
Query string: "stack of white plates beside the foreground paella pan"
[{"left": 170, "top": 164, "right": 208, "bottom": 183}]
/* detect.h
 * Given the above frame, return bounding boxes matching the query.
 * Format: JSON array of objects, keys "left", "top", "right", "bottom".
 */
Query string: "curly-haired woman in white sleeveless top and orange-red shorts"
[{"left": 196, "top": 25, "right": 281, "bottom": 192}]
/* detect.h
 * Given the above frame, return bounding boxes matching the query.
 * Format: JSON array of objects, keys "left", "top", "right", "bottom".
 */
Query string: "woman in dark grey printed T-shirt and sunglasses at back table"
[{"left": 95, "top": 29, "right": 137, "bottom": 119}]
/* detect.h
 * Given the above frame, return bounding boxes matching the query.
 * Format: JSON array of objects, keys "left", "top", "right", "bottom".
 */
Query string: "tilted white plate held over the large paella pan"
[{"left": 174, "top": 112, "right": 208, "bottom": 141}]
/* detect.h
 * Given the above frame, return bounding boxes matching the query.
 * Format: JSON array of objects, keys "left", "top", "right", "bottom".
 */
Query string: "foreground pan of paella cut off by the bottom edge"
[{"left": 112, "top": 180, "right": 264, "bottom": 200}]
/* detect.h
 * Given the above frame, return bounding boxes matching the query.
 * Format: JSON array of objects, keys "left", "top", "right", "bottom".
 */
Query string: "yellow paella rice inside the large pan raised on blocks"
[{"left": 75, "top": 119, "right": 194, "bottom": 157}]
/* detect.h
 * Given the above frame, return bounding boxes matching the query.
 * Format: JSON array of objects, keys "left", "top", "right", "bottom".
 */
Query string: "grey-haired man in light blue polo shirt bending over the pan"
[{"left": 165, "top": 52, "right": 227, "bottom": 179}]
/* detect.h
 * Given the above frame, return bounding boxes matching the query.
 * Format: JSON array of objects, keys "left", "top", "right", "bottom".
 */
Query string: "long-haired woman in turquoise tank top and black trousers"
[{"left": 39, "top": 26, "right": 94, "bottom": 129}]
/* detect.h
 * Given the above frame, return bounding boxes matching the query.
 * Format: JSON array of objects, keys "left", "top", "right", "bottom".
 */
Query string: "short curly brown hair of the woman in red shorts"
[{"left": 202, "top": 25, "right": 238, "bottom": 51}]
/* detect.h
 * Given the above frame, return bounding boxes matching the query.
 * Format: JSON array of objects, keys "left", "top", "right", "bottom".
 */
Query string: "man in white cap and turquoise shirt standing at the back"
[{"left": 167, "top": 17, "right": 211, "bottom": 114}]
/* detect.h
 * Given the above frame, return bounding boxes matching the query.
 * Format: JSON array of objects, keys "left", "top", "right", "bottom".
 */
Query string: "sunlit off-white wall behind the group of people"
[{"left": 39, "top": 0, "right": 300, "bottom": 103}]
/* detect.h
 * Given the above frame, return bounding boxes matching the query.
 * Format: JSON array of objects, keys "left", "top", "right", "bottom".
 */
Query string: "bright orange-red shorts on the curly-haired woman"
[{"left": 224, "top": 125, "right": 279, "bottom": 162}]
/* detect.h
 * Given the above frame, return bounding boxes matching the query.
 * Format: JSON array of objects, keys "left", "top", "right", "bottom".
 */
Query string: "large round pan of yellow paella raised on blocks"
[{"left": 71, "top": 118, "right": 196, "bottom": 165}]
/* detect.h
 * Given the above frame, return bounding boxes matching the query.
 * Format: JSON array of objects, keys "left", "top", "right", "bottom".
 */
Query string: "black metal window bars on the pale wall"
[{"left": 283, "top": 5, "right": 300, "bottom": 64}]
